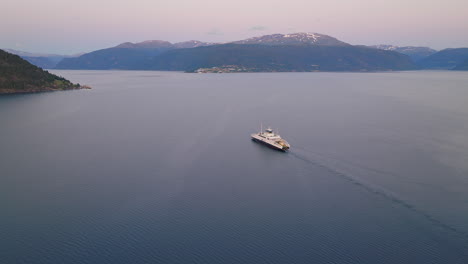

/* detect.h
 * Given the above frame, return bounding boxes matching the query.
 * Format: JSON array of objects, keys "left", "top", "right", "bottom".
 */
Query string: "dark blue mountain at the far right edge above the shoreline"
[{"left": 418, "top": 48, "right": 468, "bottom": 70}]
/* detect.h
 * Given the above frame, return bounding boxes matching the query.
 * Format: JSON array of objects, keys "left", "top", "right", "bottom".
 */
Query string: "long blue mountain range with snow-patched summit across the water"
[{"left": 56, "top": 33, "right": 416, "bottom": 71}]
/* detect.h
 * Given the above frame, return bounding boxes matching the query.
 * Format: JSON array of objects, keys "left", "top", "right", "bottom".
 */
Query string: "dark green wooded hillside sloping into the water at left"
[{"left": 0, "top": 50, "right": 89, "bottom": 94}]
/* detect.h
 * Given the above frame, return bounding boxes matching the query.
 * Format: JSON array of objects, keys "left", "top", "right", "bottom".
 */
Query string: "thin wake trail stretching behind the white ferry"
[{"left": 288, "top": 148, "right": 468, "bottom": 243}]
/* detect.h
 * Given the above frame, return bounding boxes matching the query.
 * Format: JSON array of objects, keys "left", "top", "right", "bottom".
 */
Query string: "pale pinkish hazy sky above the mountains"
[{"left": 0, "top": 0, "right": 468, "bottom": 54}]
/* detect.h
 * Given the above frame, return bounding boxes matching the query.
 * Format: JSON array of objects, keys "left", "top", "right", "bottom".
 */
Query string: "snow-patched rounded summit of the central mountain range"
[{"left": 231, "top": 33, "right": 350, "bottom": 46}]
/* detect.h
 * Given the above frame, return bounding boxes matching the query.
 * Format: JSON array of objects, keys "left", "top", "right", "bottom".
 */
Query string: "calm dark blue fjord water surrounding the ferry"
[{"left": 0, "top": 71, "right": 468, "bottom": 264}]
